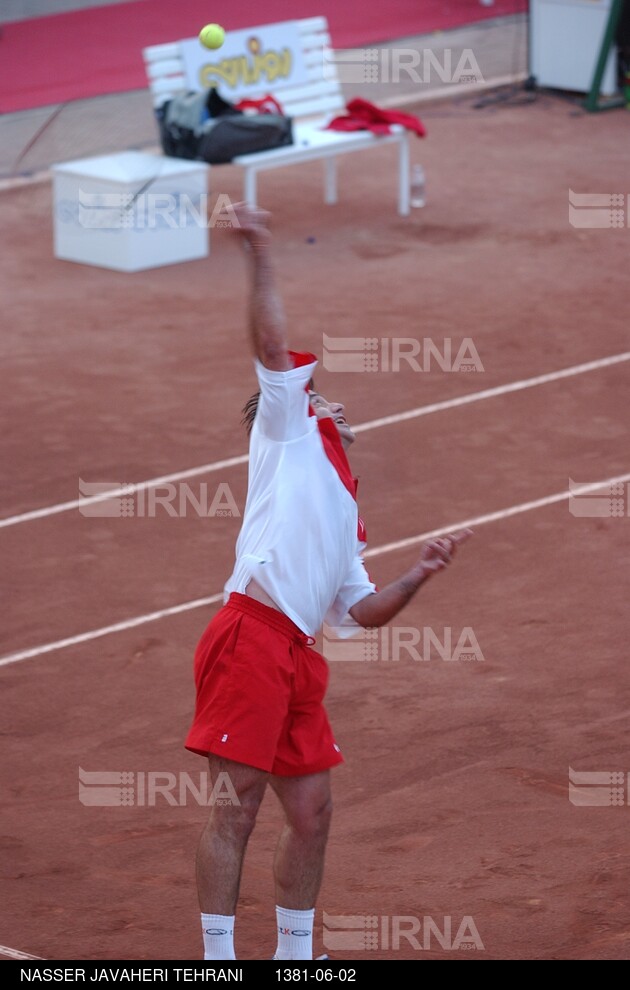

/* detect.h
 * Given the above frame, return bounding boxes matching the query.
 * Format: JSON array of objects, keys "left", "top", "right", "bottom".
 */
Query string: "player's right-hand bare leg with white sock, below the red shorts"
[{"left": 270, "top": 770, "right": 332, "bottom": 959}]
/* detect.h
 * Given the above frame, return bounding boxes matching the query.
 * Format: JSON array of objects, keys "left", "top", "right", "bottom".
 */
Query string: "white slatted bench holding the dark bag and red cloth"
[{"left": 142, "top": 17, "right": 409, "bottom": 216}]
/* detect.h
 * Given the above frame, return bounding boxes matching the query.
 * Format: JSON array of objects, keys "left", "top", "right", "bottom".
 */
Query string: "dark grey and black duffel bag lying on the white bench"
[{"left": 156, "top": 89, "right": 293, "bottom": 165}]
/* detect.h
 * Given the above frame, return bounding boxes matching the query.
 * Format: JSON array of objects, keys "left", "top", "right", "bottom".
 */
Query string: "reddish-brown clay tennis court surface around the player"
[{"left": 0, "top": 50, "right": 630, "bottom": 961}]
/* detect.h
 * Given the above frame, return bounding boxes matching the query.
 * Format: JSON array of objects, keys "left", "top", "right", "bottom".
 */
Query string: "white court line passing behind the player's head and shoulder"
[{"left": 0, "top": 351, "right": 630, "bottom": 529}]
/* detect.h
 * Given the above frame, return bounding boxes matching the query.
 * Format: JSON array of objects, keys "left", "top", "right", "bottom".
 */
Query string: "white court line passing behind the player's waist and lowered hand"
[{"left": 0, "top": 473, "right": 630, "bottom": 667}]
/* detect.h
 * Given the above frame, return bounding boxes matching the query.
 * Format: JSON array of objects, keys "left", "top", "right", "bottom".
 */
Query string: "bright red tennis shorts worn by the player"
[{"left": 185, "top": 592, "right": 343, "bottom": 777}]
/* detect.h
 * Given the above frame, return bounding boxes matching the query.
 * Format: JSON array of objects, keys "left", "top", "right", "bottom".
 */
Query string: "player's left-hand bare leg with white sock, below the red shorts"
[{"left": 196, "top": 754, "right": 269, "bottom": 959}]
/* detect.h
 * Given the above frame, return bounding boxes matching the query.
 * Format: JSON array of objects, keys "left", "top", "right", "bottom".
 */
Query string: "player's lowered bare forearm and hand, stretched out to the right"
[{"left": 350, "top": 529, "right": 472, "bottom": 629}]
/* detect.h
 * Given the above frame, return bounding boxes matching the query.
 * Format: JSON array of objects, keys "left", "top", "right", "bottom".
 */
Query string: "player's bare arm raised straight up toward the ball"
[{"left": 233, "top": 203, "right": 293, "bottom": 371}]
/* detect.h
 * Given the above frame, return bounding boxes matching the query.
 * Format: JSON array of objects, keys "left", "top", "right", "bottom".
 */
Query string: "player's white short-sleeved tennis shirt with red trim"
[{"left": 224, "top": 352, "right": 376, "bottom": 637}]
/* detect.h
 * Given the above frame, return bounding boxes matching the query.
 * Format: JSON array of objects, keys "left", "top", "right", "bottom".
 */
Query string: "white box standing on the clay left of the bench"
[{"left": 52, "top": 151, "right": 210, "bottom": 272}]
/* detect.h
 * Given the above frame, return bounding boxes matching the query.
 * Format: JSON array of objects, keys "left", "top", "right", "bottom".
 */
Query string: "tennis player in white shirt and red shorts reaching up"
[{"left": 185, "top": 203, "right": 470, "bottom": 960}]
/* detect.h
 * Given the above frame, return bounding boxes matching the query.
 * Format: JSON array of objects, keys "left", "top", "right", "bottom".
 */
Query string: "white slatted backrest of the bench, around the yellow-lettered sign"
[{"left": 142, "top": 17, "right": 344, "bottom": 118}]
